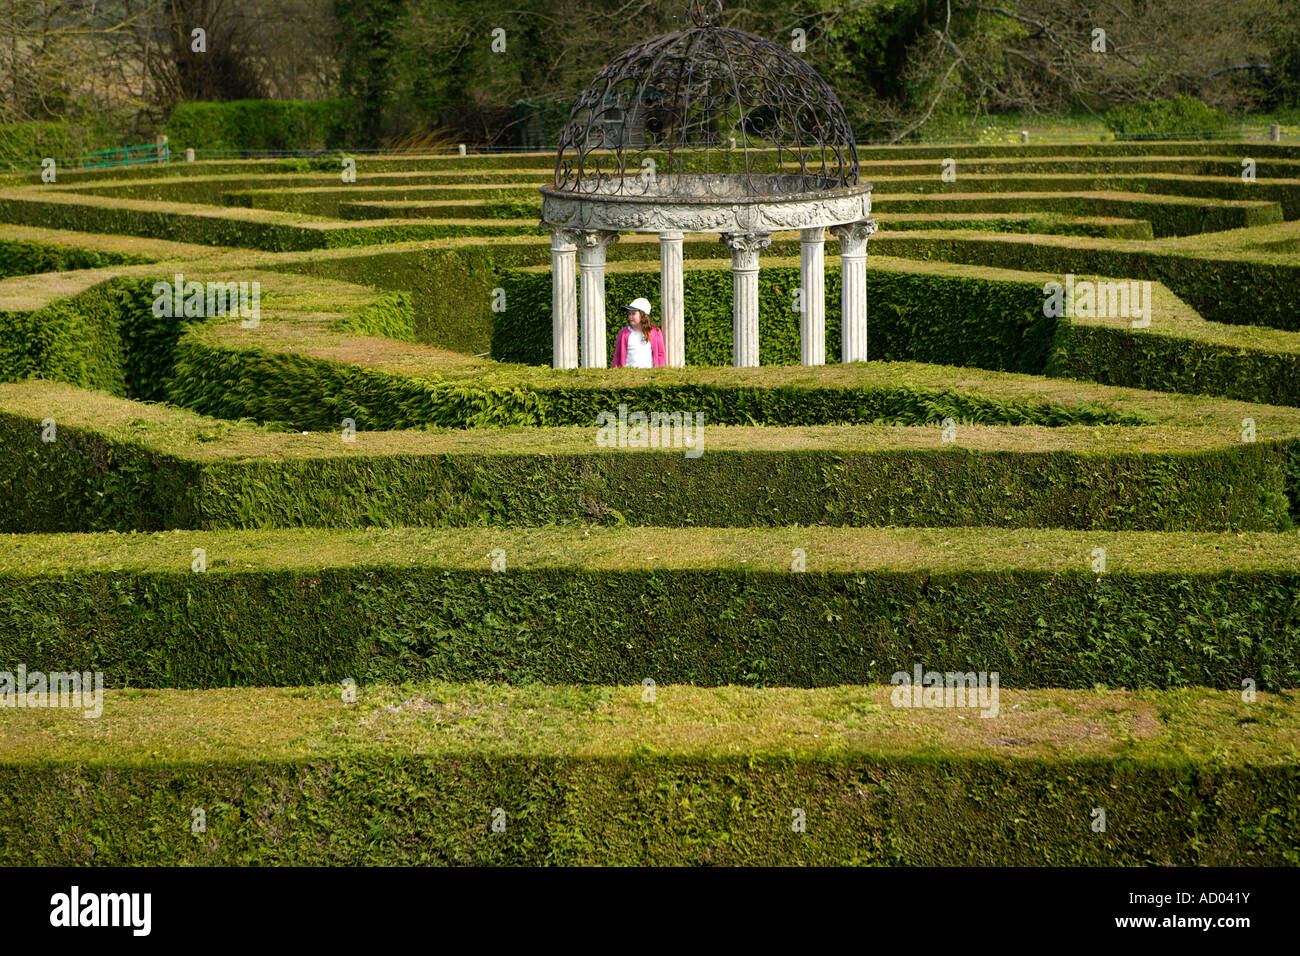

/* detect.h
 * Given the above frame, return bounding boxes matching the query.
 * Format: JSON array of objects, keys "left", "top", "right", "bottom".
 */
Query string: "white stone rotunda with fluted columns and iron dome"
[{"left": 541, "top": 0, "right": 876, "bottom": 368}]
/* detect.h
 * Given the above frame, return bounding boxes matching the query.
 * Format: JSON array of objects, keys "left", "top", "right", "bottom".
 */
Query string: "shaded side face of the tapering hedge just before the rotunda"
[{"left": 165, "top": 328, "right": 1170, "bottom": 431}]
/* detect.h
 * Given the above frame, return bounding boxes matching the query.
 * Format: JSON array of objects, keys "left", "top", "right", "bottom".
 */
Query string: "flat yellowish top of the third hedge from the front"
[{"left": 0, "top": 377, "right": 1300, "bottom": 462}]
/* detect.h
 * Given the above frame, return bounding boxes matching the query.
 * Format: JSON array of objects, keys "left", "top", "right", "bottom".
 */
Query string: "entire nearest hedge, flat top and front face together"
[{"left": 0, "top": 687, "right": 1300, "bottom": 866}]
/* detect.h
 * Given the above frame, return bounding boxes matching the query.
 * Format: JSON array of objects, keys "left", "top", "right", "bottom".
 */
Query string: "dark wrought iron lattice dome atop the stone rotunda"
[{"left": 542, "top": 0, "right": 858, "bottom": 202}]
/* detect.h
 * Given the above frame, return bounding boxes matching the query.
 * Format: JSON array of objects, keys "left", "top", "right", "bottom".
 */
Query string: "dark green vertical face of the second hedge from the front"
[{"left": 0, "top": 556, "right": 1300, "bottom": 689}]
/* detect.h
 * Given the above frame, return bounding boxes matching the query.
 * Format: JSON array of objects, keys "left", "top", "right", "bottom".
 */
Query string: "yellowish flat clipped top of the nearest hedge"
[{"left": 0, "top": 683, "right": 1300, "bottom": 766}]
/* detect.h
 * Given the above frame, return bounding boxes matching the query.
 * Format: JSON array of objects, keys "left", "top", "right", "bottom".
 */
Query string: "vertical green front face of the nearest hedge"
[{"left": 0, "top": 752, "right": 1300, "bottom": 866}]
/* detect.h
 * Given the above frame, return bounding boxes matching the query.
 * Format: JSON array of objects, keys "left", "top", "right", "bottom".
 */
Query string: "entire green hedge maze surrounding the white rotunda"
[{"left": 0, "top": 142, "right": 1300, "bottom": 865}]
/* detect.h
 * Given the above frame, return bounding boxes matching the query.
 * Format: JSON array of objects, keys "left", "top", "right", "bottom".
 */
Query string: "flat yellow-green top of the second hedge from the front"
[{"left": 0, "top": 525, "right": 1300, "bottom": 579}]
